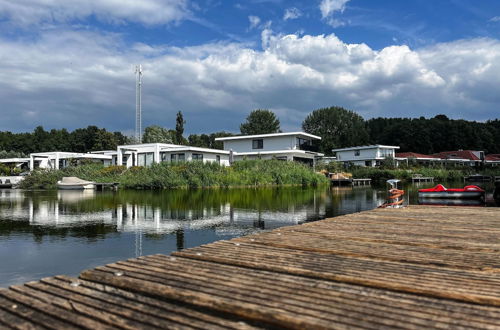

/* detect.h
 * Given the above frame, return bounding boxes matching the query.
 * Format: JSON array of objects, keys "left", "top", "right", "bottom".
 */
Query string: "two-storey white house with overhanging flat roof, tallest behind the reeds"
[{"left": 215, "top": 132, "right": 323, "bottom": 165}]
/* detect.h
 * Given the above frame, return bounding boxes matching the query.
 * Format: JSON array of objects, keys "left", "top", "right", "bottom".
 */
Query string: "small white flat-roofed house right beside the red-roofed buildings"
[{"left": 332, "top": 144, "right": 399, "bottom": 167}]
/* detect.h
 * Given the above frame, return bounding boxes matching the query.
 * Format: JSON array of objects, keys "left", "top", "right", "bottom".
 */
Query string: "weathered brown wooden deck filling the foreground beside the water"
[{"left": 0, "top": 206, "right": 500, "bottom": 329}]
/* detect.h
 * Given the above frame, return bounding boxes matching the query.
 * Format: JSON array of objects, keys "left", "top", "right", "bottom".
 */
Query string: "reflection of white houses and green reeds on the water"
[{"left": 0, "top": 188, "right": 384, "bottom": 249}]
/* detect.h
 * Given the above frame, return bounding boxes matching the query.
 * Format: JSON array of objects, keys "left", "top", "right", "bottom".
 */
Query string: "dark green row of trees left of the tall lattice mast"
[{"left": 0, "top": 126, "right": 128, "bottom": 154}]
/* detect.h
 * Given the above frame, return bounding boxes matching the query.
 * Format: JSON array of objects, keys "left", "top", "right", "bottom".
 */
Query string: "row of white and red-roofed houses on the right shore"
[{"left": 332, "top": 144, "right": 500, "bottom": 167}]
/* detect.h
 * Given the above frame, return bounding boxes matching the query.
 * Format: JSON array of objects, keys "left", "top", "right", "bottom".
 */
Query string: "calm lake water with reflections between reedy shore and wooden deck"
[{"left": 0, "top": 185, "right": 498, "bottom": 287}]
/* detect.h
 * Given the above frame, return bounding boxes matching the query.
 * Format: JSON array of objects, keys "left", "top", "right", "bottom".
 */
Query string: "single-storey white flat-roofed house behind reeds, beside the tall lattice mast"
[{"left": 116, "top": 143, "right": 229, "bottom": 167}]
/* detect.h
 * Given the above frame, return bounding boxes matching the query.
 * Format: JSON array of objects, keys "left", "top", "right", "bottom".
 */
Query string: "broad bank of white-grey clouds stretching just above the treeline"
[{"left": 0, "top": 30, "right": 500, "bottom": 132}]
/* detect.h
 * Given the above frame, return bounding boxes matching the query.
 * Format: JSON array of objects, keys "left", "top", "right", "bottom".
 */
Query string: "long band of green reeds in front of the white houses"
[{"left": 20, "top": 160, "right": 328, "bottom": 189}]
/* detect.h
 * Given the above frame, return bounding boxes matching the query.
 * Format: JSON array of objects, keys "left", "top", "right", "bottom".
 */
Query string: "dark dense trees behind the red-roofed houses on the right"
[{"left": 366, "top": 115, "right": 500, "bottom": 154}]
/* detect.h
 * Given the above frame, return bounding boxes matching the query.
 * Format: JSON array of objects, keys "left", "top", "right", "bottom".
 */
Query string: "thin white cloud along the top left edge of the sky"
[{"left": 0, "top": 0, "right": 188, "bottom": 26}]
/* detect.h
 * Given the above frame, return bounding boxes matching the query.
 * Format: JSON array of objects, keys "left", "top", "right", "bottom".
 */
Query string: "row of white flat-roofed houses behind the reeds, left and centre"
[{"left": 0, "top": 132, "right": 323, "bottom": 170}]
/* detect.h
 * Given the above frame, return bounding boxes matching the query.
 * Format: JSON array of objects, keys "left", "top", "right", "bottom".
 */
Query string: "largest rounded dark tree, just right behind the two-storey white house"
[{"left": 302, "top": 107, "right": 369, "bottom": 155}]
